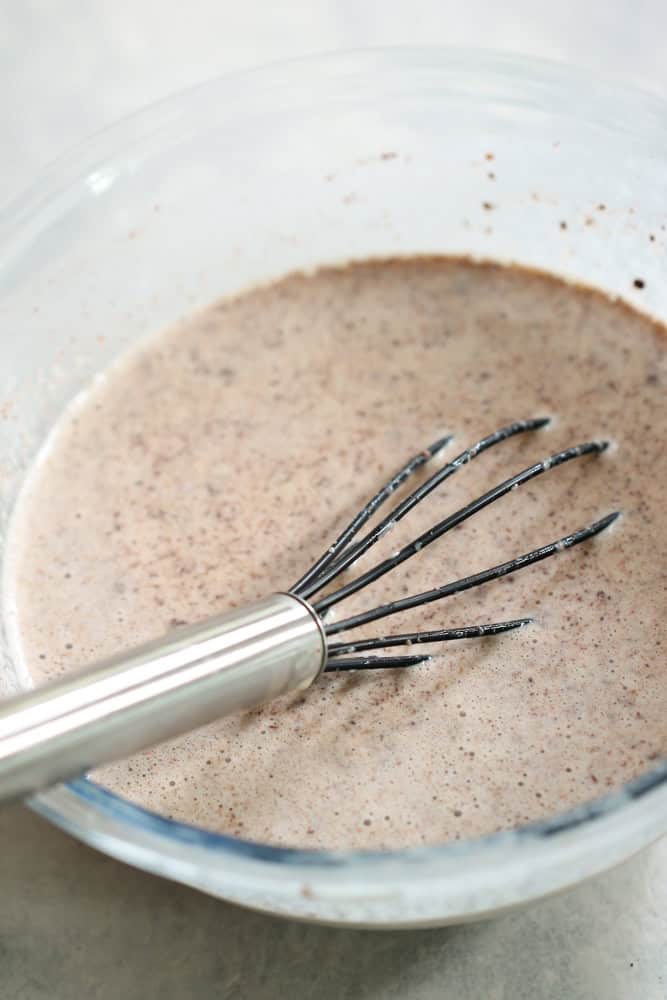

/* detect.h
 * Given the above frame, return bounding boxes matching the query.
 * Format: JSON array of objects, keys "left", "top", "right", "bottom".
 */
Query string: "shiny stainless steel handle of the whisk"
[{"left": 0, "top": 594, "right": 326, "bottom": 801}]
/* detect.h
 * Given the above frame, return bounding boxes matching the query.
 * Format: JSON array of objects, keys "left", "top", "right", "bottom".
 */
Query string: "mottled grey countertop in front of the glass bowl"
[{"left": 0, "top": 806, "right": 667, "bottom": 1000}]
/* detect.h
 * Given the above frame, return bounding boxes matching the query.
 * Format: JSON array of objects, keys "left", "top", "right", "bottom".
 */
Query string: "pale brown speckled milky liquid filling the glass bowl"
[{"left": 15, "top": 259, "right": 667, "bottom": 848}]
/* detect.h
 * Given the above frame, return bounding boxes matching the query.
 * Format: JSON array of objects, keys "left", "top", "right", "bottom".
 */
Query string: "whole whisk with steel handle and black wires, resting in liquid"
[{"left": 0, "top": 417, "right": 619, "bottom": 800}]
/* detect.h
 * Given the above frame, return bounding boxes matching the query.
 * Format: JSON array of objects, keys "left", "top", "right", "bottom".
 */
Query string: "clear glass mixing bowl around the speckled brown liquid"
[{"left": 0, "top": 49, "right": 667, "bottom": 927}]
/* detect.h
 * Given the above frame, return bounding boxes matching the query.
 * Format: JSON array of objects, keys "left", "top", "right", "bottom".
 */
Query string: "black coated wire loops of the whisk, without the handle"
[{"left": 291, "top": 417, "right": 620, "bottom": 671}]
